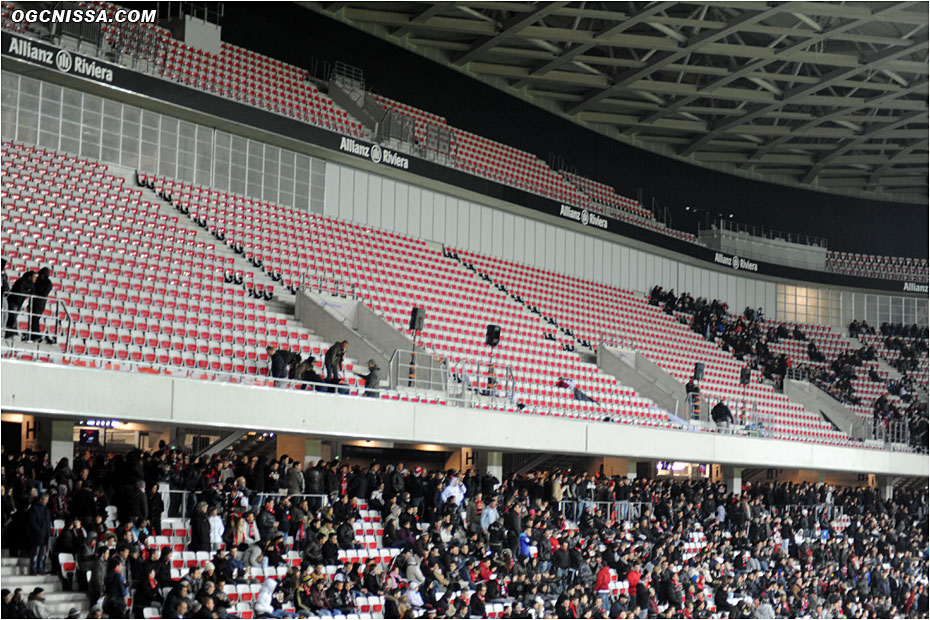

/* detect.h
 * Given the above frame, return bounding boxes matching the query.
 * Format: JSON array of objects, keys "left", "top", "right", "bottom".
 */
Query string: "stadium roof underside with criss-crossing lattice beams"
[{"left": 299, "top": 1, "right": 930, "bottom": 203}]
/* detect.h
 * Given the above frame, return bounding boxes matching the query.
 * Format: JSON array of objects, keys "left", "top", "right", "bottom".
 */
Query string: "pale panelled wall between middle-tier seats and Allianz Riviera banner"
[{"left": 0, "top": 66, "right": 927, "bottom": 327}]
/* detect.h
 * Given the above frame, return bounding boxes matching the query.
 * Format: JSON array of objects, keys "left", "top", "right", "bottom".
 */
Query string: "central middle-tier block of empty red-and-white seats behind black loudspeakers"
[{"left": 146, "top": 172, "right": 667, "bottom": 425}]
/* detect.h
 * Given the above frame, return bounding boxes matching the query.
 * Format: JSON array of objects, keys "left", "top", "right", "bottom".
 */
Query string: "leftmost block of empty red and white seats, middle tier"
[{"left": 0, "top": 143, "right": 364, "bottom": 383}]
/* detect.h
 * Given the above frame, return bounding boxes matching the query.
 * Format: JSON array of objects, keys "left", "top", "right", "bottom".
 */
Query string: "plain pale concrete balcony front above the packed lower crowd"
[{"left": 0, "top": 360, "right": 927, "bottom": 477}]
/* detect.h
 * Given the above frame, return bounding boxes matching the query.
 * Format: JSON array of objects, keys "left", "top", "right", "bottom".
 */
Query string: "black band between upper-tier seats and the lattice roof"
[{"left": 216, "top": 2, "right": 928, "bottom": 257}]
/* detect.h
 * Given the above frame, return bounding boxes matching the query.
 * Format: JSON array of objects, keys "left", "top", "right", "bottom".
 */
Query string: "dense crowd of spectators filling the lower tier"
[{"left": 3, "top": 447, "right": 928, "bottom": 618}]
